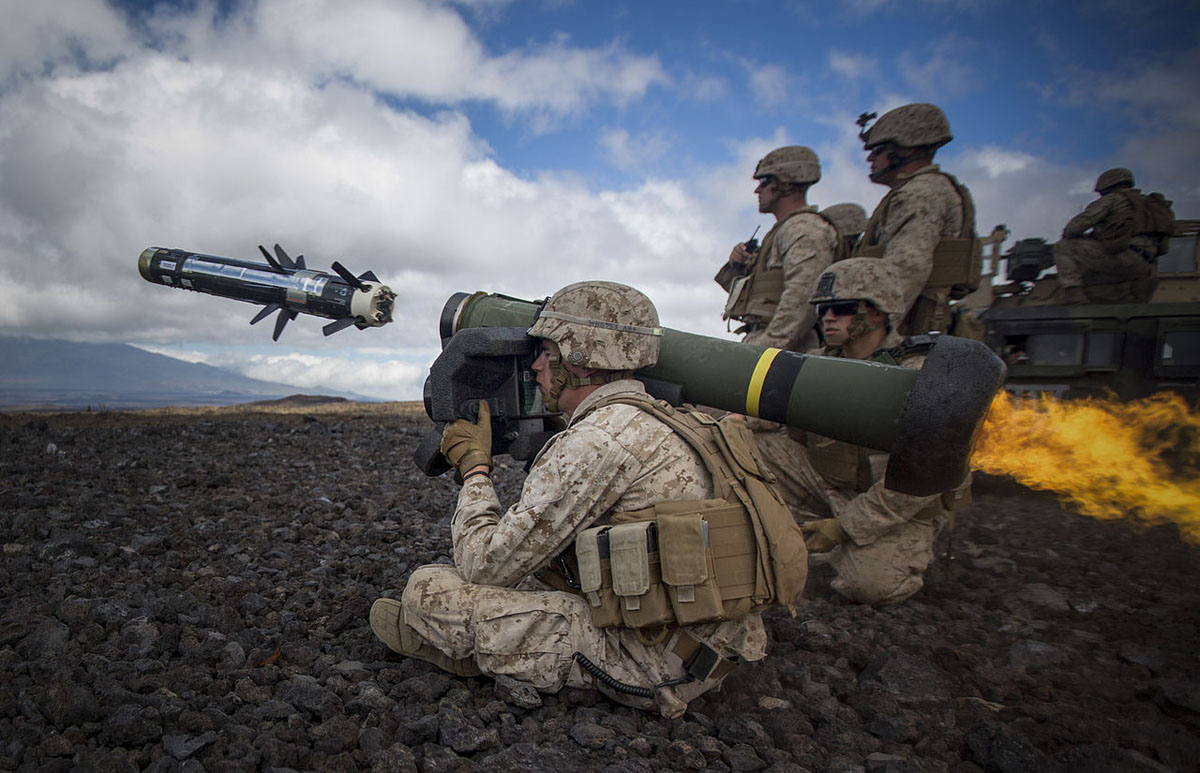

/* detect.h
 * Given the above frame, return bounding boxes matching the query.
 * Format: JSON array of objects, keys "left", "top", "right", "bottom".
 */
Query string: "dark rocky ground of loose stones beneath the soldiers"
[{"left": 0, "top": 407, "right": 1200, "bottom": 773}]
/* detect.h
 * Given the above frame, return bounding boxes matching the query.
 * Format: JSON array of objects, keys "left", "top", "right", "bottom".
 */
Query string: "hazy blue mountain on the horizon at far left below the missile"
[{"left": 0, "top": 337, "right": 368, "bottom": 411}]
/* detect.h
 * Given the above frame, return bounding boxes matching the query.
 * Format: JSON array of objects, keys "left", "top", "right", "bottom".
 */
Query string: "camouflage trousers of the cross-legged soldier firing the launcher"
[{"left": 401, "top": 564, "right": 739, "bottom": 718}]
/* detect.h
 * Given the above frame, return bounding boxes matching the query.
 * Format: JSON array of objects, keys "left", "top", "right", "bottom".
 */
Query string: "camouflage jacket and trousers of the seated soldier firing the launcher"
[{"left": 403, "top": 379, "right": 767, "bottom": 717}]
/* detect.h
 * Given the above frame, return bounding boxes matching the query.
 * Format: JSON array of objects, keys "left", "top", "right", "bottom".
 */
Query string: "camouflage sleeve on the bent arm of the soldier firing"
[{"left": 450, "top": 422, "right": 640, "bottom": 587}]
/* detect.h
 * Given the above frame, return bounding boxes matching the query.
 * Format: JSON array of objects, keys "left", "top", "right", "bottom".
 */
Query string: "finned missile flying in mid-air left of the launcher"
[{"left": 138, "top": 245, "right": 396, "bottom": 341}]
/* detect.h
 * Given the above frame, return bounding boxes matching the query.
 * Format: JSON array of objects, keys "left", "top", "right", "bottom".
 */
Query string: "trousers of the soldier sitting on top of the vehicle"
[{"left": 1054, "top": 239, "right": 1158, "bottom": 304}]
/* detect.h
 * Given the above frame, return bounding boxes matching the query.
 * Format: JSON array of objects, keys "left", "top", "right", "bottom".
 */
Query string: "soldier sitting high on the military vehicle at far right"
[{"left": 1054, "top": 168, "right": 1175, "bottom": 304}]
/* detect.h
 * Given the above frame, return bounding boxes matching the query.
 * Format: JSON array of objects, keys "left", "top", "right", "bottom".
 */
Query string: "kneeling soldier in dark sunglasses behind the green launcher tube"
[{"left": 764, "top": 258, "right": 971, "bottom": 605}]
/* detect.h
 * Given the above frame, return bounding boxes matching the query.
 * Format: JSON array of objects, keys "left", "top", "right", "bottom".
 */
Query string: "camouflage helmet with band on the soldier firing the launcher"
[{"left": 529, "top": 281, "right": 662, "bottom": 371}]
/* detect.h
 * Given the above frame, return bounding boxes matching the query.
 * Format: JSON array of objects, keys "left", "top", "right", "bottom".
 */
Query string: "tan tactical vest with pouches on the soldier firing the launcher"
[{"left": 549, "top": 394, "right": 808, "bottom": 635}]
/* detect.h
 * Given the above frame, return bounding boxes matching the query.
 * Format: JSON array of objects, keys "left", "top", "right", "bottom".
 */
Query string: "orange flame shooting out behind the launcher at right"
[{"left": 972, "top": 391, "right": 1200, "bottom": 544}]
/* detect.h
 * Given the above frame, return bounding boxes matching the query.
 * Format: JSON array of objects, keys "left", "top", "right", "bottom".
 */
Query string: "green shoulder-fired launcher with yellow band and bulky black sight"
[{"left": 414, "top": 293, "right": 1004, "bottom": 496}]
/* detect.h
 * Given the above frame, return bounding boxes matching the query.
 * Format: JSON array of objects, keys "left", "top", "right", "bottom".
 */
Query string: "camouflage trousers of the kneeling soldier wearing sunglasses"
[{"left": 755, "top": 430, "right": 950, "bottom": 606}]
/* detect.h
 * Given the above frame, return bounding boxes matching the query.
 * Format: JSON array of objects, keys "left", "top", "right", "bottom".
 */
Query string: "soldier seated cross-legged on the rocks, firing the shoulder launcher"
[{"left": 371, "top": 282, "right": 808, "bottom": 718}]
